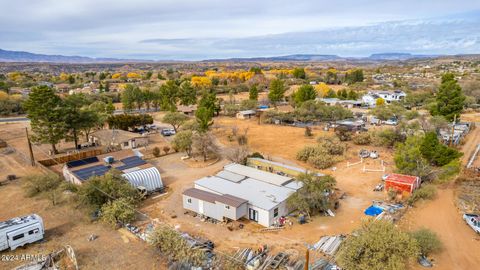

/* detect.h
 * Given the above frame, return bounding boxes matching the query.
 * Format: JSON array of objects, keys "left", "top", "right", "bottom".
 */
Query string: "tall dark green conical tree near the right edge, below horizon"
[{"left": 430, "top": 73, "right": 465, "bottom": 121}]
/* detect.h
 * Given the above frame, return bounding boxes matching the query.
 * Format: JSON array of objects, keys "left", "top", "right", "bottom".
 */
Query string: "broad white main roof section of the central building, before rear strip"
[{"left": 195, "top": 175, "right": 295, "bottom": 210}]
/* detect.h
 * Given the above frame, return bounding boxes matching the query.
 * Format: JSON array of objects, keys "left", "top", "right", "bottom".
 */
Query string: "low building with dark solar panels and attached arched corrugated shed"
[{"left": 63, "top": 150, "right": 163, "bottom": 191}]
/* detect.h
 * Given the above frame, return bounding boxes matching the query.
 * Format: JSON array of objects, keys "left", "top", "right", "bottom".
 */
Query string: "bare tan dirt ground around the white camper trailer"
[{"left": 0, "top": 151, "right": 165, "bottom": 269}]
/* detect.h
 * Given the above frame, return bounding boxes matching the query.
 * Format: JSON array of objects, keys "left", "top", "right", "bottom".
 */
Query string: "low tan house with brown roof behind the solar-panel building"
[{"left": 89, "top": 129, "right": 148, "bottom": 149}]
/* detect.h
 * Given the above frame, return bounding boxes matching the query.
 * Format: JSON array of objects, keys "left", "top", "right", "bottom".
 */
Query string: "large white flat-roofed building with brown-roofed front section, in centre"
[{"left": 183, "top": 163, "right": 302, "bottom": 227}]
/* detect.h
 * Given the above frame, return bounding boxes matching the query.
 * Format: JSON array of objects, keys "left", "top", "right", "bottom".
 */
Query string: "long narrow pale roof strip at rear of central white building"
[{"left": 223, "top": 163, "right": 293, "bottom": 186}]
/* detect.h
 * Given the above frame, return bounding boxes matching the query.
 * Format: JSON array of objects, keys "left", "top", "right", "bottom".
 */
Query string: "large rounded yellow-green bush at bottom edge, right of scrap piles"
[{"left": 338, "top": 220, "right": 419, "bottom": 270}]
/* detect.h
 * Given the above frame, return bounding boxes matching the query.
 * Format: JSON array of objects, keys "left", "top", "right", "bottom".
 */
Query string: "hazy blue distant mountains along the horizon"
[{"left": 0, "top": 49, "right": 440, "bottom": 63}]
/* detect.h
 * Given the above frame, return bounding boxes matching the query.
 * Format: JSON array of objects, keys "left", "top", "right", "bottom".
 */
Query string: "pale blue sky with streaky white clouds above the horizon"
[{"left": 0, "top": 0, "right": 480, "bottom": 60}]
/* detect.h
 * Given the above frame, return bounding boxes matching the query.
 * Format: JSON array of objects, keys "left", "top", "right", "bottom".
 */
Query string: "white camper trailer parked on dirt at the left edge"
[{"left": 0, "top": 214, "right": 45, "bottom": 251}]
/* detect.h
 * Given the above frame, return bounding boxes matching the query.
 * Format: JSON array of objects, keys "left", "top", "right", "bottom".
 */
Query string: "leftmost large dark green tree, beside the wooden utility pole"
[{"left": 23, "top": 86, "right": 67, "bottom": 154}]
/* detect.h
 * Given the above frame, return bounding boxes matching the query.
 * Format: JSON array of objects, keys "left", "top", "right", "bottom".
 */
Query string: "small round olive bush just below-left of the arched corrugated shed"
[{"left": 101, "top": 198, "right": 135, "bottom": 227}]
